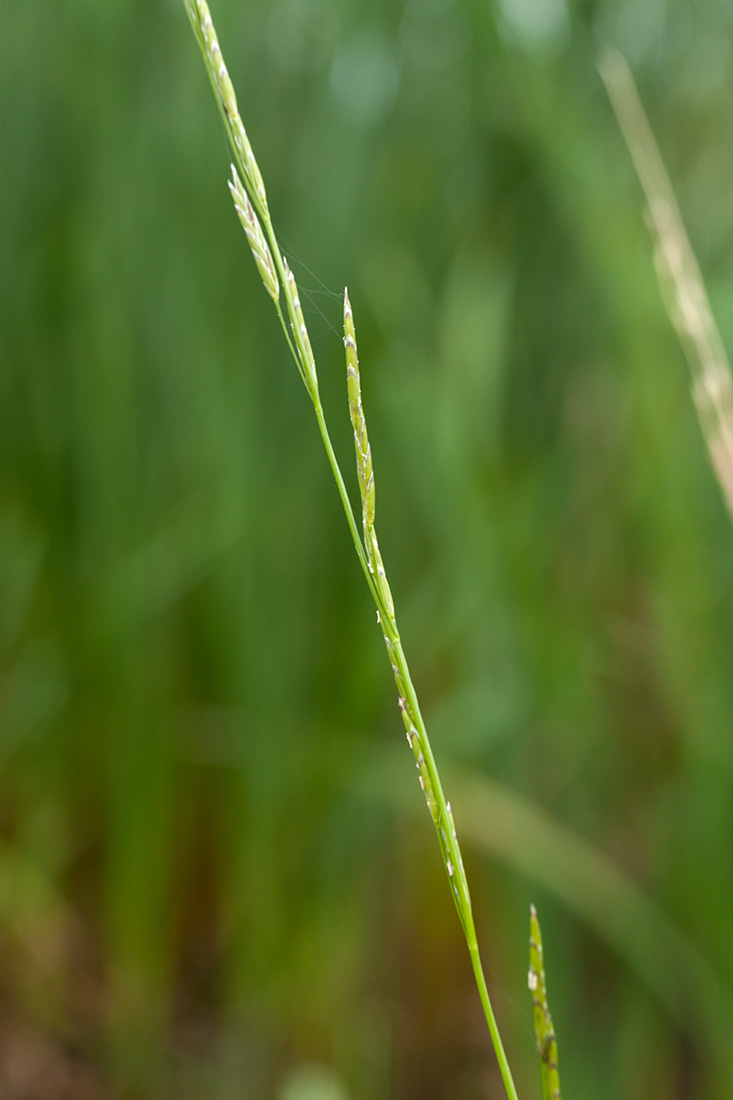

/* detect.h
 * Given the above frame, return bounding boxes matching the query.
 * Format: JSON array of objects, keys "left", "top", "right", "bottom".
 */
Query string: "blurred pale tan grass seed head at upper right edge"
[{"left": 599, "top": 50, "right": 733, "bottom": 516}]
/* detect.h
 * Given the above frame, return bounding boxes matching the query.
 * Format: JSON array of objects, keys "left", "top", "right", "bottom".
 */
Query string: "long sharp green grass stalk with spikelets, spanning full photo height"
[{"left": 179, "top": 0, "right": 517, "bottom": 1100}]
